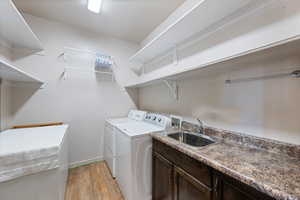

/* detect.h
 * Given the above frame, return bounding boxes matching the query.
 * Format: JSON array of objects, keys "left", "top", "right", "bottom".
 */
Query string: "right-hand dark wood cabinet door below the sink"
[{"left": 174, "top": 167, "right": 212, "bottom": 200}]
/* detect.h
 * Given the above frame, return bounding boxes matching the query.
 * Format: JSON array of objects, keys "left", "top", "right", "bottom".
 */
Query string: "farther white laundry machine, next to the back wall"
[{"left": 104, "top": 110, "right": 146, "bottom": 178}]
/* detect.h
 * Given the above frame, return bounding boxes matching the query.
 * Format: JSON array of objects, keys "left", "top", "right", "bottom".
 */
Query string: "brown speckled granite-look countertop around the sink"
[{"left": 152, "top": 128, "right": 300, "bottom": 200}]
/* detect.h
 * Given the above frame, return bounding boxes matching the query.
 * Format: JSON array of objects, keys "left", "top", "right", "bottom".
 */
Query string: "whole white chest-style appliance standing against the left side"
[{"left": 0, "top": 125, "right": 68, "bottom": 200}]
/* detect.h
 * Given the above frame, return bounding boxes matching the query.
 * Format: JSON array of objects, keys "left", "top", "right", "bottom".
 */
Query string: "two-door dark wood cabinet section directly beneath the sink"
[{"left": 152, "top": 140, "right": 212, "bottom": 200}]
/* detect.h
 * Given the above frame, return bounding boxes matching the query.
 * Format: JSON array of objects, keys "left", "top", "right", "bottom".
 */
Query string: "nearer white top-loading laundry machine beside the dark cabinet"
[{"left": 116, "top": 113, "right": 170, "bottom": 200}]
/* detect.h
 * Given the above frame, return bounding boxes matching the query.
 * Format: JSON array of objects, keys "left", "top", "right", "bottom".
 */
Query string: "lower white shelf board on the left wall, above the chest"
[{"left": 0, "top": 60, "right": 43, "bottom": 84}]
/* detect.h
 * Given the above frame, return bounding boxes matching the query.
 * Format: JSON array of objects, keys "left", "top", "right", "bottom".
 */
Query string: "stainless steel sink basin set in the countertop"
[{"left": 168, "top": 132, "right": 215, "bottom": 147}]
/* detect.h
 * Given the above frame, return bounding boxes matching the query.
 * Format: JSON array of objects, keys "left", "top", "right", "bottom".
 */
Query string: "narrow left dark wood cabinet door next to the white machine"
[{"left": 152, "top": 153, "right": 174, "bottom": 200}]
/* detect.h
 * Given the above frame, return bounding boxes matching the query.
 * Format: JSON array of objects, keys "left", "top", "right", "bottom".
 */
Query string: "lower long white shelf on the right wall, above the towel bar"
[{"left": 126, "top": 0, "right": 300, "bottom": 88}]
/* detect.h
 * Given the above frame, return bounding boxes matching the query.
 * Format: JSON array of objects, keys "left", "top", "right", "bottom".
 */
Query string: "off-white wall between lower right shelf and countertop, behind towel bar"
[{"left": 139, "top": 42, "right": 300, "bottom": 144}]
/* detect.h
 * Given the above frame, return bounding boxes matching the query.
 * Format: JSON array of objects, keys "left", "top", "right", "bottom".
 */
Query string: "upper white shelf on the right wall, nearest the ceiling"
[{"left": 130, "top": 0, "right": 269, "bottom": 63}]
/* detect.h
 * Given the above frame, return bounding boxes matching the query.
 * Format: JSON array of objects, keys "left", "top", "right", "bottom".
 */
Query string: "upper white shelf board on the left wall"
[{"left": 0, "top": 0, "right": 43, "bottom": 51}]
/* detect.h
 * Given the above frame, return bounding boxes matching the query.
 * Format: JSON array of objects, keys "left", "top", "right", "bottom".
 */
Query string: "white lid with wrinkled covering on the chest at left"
[{"left": 0, "top": 125, "right": 68, "bottom": 182}]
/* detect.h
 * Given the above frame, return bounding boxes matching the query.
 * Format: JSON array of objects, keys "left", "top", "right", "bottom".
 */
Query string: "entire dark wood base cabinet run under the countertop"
[{"left": 152, "top": 139, "right": 275, "bottom": 200}]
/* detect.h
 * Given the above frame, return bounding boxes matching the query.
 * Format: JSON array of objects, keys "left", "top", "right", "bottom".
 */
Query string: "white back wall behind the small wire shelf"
[{"left": 10, "top": 14, "right": 138, "bottom": 164}]
